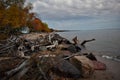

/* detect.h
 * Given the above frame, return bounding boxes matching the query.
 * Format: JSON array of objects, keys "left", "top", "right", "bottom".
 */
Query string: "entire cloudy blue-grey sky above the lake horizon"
[{"left": 27, "top": 0, "right": 120, "bottom": 30}]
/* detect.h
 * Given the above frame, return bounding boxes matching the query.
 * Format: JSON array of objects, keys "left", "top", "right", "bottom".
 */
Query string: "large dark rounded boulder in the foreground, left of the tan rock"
[{"left": 52, "top": 60, "right": 81, "bottom": 78}]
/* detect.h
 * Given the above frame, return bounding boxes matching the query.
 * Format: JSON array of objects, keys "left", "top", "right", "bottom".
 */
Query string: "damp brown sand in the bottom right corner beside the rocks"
[{"left": 79, "top": 56, "right": 120, "bottom": 80}]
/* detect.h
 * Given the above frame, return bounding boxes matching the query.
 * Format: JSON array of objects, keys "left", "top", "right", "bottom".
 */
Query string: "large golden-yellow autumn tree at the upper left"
[{"left": 0, "top": 0, "right": 32, "bottom": 32}]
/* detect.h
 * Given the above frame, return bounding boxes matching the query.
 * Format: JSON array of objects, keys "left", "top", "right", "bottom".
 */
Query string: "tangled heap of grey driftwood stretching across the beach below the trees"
[{"left": 0, "top": 33, "right": 73, "bottom": 54}]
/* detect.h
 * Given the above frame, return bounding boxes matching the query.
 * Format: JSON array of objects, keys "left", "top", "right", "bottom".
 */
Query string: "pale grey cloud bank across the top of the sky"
[{"left": 26, "top": 0, "right": 120, "bottom": 19}]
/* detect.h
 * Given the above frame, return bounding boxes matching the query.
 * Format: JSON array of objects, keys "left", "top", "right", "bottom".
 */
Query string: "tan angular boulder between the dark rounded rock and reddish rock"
[{"left": 70, "top": 56, "right": 94, "bottom": 78}]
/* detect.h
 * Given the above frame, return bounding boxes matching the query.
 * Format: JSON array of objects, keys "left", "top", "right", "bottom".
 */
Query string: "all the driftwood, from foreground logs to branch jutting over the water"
[{"left": 0, "top": 34, "right": 95, "bottom": 80}]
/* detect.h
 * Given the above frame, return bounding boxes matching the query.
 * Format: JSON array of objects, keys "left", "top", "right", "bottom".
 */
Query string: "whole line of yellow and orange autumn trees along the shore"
[{"left": 0, "top": 0, "right": 51, "bottom": 34}]
